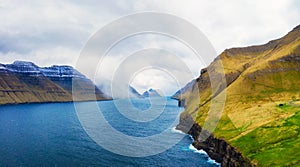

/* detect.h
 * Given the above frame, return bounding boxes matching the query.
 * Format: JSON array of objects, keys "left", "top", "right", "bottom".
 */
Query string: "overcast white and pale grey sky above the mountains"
[{"left": 0, "top": 0, "right": 300, "bottom": 96}]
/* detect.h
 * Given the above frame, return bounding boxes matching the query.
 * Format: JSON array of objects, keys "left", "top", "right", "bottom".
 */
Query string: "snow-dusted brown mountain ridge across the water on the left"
[{"left": 0, "top": 61, "right": 109, "bottom": 104}]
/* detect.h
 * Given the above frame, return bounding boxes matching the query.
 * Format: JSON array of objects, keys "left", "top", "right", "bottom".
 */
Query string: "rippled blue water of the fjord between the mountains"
[{"left": 0, "top": 98, "right": 219, "bottom": 167}]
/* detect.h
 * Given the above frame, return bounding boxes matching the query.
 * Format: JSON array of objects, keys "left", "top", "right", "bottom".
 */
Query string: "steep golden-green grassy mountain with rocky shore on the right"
[{"left": 173, "top": 25, "right": 300, "bottom": 166}]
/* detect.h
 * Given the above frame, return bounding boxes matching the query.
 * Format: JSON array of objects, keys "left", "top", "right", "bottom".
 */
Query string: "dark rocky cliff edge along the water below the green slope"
[{"left": 176, "top": 117, "right": 254, "bottom": 167}]
